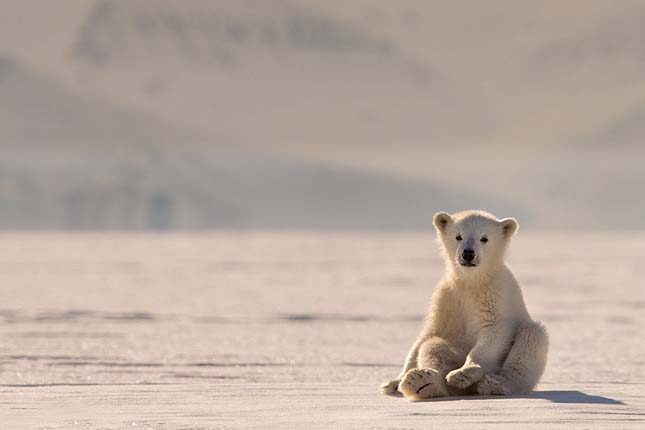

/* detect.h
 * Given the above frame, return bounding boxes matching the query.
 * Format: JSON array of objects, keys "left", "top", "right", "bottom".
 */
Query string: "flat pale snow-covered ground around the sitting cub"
[{"left": 0, "top": 233, "right": 645, "bottom": 429}]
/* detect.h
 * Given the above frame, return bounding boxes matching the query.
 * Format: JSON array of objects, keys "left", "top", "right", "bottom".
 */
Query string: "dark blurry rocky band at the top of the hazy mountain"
[{"left": 76, "top": 0, "right": 395, "bottom": 65}]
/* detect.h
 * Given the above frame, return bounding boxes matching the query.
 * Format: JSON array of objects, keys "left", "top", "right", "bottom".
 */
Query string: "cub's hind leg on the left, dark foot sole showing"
[{"left": 399, "top": 337, "right": 466, "bottom": 400}]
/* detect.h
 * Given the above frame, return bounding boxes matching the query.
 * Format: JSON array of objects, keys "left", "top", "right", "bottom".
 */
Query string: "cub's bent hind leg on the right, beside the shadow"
[{"left": 477, "top": 322, "right": 549, "bottom": 395}]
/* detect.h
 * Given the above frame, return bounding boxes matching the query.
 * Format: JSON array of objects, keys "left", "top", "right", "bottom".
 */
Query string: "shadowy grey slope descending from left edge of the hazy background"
[{"left": 0, "top": 57, "right": 196, "bottom": 151}]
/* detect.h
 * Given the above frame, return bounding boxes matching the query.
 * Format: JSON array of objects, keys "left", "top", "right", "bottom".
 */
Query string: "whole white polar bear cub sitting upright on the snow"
[{"left": 381, "top": 211, "right": 548, "bottom": 400}]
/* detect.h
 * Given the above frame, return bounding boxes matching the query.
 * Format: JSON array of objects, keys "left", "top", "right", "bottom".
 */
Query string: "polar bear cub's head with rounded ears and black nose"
[{"left": 433, "top": 211, "right": 518, "bottom": 275}]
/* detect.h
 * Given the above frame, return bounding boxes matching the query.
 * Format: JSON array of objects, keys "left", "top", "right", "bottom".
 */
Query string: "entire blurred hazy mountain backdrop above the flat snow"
[{"left": 0, "top": 0, "right": 645, "bottom": 229}]
